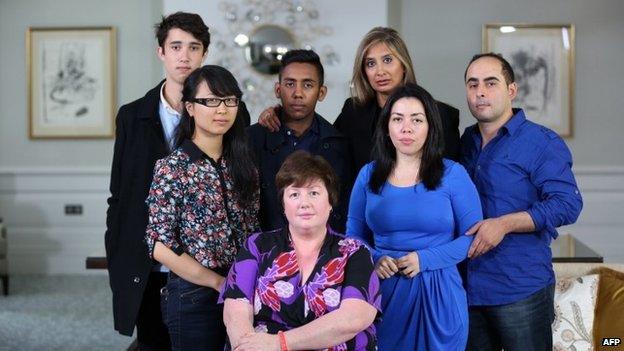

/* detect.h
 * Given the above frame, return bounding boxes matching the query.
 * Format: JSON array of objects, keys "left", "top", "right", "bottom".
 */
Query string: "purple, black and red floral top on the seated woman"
[{"left": 221, "top": 229, "right": 381, "bottom": 350}]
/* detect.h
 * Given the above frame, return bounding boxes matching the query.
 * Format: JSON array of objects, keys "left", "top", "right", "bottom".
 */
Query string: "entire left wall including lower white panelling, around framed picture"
[{"left": 0, "top": 0, "right": 162, "bottom": 273}]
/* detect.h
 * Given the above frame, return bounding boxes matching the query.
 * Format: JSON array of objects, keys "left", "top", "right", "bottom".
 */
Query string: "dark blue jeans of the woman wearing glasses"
[{"left": 160, "top": 273, "right": 226, "bottom": 351}]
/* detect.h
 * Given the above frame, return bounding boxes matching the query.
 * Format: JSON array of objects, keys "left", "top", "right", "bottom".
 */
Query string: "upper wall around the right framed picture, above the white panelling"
[{"left": 391, "top": 0, "right": 624, "bottom": 167}]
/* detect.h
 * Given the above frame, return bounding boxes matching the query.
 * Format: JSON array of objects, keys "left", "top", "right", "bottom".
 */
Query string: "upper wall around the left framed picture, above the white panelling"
[{"left": 0, "top": 0, "right": 161, "bottom": 169}]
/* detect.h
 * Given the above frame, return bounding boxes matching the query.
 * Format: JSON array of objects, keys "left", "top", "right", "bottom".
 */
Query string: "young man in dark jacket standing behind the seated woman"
[{"left": 248, "top": 50, "right": 353, "bottom": 233}]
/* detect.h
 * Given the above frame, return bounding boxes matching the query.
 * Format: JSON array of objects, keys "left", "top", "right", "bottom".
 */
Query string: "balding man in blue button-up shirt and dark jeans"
[{"left": 461, "top": 53, "right": 583, "bottom": 350}]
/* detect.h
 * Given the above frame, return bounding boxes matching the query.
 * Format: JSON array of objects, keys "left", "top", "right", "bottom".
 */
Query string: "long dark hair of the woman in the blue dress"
[{"left": 369, "top": 83, "right": 444, "bottom": 194}]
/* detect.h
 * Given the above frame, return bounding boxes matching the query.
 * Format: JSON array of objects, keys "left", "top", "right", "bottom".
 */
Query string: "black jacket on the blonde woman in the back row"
[{"left": 334, "top": 98, "right": 459, "bottom": 173}]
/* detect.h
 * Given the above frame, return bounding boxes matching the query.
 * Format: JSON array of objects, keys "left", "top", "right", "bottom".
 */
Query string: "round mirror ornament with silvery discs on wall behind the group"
[{"left": 209, "top": 0, "right": 340, "bottom": 120}]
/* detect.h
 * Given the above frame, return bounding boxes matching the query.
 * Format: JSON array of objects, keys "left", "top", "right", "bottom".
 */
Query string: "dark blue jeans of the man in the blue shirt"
[{"left": 466, "top": 285, "right": 555, "bottom": 351}]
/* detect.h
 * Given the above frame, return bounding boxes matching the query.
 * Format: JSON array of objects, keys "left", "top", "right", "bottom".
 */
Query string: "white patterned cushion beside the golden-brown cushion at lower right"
[{"left": 552, "top": 274, "right": 598, "bottom": 351}]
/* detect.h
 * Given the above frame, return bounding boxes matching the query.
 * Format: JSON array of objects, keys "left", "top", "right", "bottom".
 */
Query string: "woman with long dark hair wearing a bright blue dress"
[{"left": 347, "top": 84, "right": 482, "bottom": 351}]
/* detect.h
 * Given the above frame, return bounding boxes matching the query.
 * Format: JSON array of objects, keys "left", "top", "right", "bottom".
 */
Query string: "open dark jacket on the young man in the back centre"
[{"left": 247, "top": 114, "right": 355, "bottom": 233}]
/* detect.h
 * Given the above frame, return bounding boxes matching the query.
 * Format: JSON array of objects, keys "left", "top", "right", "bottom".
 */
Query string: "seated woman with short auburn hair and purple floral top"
[{"left": 222, "top": 151, "right": 381, "bottom": 351}]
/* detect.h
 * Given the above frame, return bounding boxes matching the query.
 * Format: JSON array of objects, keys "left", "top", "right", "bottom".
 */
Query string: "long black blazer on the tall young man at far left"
[{"left": 104, "top": 81, "right": 249, "bottom": 336}]
